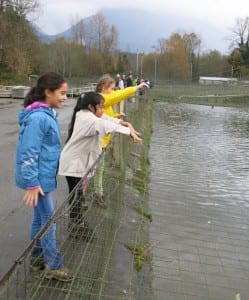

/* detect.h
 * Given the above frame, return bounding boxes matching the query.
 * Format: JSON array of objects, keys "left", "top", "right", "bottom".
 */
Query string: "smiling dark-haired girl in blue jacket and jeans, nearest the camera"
[{"left": 15, "top": 72, "right": 72, "bottom": 281}]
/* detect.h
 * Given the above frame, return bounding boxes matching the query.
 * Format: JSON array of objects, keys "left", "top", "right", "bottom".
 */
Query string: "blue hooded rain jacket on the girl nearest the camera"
[{"left": 15, "top": 107, "right": 61, "bottom": 192}]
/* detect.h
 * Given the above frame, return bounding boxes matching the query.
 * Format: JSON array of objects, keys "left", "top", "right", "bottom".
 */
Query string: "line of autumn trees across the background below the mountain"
[{"left": 0, "top": 0, "right": 249, "bottom": 83}]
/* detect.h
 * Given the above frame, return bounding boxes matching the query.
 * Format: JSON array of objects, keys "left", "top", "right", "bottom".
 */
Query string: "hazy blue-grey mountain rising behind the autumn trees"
[{"left": 35, "top": 9, "right": 228, "bottom": 53}]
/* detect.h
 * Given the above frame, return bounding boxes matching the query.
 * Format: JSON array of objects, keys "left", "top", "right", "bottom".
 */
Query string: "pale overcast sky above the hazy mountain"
[{"left": 35, "top": 0, "right": 249, "bottom": 34}]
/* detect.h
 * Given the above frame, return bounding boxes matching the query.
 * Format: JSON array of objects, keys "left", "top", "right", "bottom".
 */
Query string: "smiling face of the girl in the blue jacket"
[{"left": 44, "top": 82, "right": 68, "bottom": 108}]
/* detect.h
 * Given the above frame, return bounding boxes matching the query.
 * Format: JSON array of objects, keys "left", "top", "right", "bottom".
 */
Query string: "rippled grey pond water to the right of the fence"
[{"left": 149, "top": 103, "right": 249, "bottom": 300}]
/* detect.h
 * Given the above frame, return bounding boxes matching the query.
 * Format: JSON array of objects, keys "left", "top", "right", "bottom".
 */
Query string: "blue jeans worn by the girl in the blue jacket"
[{"left": 30, "top": 193, "right": 63, "bottom": 270}]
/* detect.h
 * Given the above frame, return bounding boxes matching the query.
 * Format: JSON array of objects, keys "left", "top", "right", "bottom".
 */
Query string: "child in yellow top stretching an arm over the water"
[{"left": 94, "top": 74, "right": 148, "bottom": 207}]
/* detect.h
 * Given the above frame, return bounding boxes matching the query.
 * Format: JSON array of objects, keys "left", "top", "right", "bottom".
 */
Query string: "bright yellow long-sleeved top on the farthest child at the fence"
[{"left": 102, "top": 86, "right": 137, "bottom": 148}]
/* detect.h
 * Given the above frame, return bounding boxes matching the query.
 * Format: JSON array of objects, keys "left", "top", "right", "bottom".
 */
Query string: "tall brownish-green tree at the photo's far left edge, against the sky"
[{"left": 0, "top": 0, "right": 40, "bottom": 76}]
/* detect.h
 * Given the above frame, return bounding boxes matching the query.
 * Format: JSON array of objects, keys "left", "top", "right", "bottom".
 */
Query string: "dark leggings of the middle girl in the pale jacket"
[{"left": 66, "top": 176, "right": 84, "bottom": 224}]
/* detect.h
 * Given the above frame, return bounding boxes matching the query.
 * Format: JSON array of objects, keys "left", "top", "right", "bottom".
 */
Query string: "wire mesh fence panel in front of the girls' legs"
[{"left": 0, "top": 151, "right": 123, "bottom": 299}]
